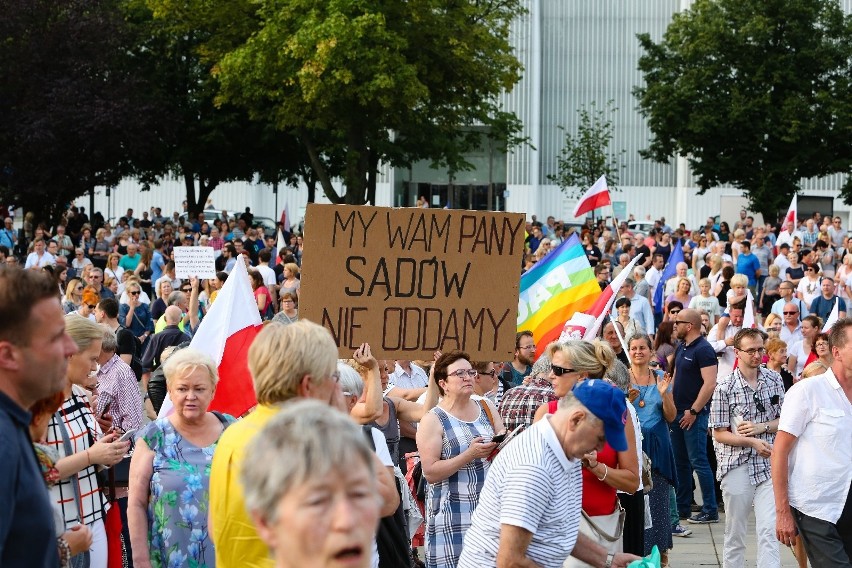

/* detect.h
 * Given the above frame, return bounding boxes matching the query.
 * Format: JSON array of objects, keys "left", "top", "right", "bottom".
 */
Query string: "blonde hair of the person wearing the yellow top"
[{"left": 248, "top": 320, "right": 337, "bottom": 404}]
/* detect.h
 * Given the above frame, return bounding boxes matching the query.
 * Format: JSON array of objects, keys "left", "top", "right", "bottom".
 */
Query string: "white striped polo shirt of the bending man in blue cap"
[{"left": 458, "top": 418, "right": 583, "bottom": 568}]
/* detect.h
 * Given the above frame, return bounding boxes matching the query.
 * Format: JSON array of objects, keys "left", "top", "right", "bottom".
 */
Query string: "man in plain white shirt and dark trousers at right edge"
[{"left": 772, "top": 318, "right": 852, "bottom": 567}]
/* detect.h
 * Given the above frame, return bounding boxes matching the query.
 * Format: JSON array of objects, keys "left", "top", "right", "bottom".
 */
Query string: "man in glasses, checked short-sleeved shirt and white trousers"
[{"left": 710, "top": 328, "right": 784, "bottom": 568}]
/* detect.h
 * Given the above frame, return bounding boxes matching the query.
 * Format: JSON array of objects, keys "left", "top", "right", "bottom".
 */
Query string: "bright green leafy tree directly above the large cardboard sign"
[{"left": 154, "top": 0, "right": 522, "bottom": 204}]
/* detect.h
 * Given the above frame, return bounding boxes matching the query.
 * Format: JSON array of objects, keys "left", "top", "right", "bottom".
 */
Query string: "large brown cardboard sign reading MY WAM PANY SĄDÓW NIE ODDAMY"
[{"left": 299, "top": 204, "right": 524, "bottom": 361}]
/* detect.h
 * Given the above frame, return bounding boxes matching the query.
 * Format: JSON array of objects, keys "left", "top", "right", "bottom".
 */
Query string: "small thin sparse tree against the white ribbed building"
[{"left": 547, "top": 101, "right": 626, "bottom": 197}]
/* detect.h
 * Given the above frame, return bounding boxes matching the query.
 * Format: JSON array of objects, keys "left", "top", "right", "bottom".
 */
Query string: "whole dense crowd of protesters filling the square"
[{"left": 0, "top": 207, "right": 852, "bottom": 568}]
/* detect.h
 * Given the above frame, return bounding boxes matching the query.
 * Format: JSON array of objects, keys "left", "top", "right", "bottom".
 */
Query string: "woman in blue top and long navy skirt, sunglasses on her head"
[{"left": 628, "top": 335, "right": 677, "bottom": 565}]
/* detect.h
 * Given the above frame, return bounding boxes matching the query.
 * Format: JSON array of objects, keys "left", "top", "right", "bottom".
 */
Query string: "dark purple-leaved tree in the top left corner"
[{"left": 0, "top": 0, "right": 161, "bottom": 222}]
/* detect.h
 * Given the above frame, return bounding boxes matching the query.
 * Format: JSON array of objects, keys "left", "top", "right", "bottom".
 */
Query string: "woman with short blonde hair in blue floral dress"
[{"left": 127, "top": 348, "right": 234, "bottom": 568}]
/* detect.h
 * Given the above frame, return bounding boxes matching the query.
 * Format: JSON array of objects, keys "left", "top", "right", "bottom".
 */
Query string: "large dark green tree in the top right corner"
[{"left": 634, "top": 0, "right": 852, "bottom": 219}]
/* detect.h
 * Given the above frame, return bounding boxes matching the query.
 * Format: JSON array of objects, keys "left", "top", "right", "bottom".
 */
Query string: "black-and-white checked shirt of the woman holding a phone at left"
[{"left": 47, "top": 385, "right": 108, "bottom": 529}]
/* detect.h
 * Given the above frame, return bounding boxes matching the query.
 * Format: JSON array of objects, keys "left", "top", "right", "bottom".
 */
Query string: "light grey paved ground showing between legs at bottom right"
[{"left": 669, "top": 513, "right": 798, "bottom": 568}]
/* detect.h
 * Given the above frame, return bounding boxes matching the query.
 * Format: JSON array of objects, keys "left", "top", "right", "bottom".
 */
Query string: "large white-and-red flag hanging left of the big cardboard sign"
[{"left": 159, "top": 262, "right": 263, "bottom": 418}]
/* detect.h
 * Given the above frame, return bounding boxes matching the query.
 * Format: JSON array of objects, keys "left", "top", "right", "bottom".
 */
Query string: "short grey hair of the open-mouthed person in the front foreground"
[{"left": 240, "top": 399, "right": 375, "bottom": 523}]
